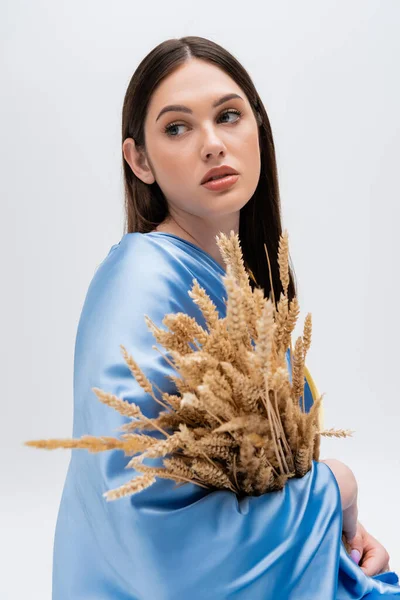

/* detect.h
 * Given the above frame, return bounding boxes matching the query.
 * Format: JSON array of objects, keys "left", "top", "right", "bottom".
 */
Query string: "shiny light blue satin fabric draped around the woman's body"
[{"left": 52, "top": 232, "right": 400, "bottom": 600}]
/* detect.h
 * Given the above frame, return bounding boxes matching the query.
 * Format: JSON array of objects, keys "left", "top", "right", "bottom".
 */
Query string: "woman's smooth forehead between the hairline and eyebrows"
[{"left": 148, "top": 59, "right": 246, "bottom": 119}]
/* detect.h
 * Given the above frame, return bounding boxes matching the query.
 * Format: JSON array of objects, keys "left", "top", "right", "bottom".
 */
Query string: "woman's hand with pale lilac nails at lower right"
[{"left": 348, "top": 521, "right": 390, "bottom": 577}]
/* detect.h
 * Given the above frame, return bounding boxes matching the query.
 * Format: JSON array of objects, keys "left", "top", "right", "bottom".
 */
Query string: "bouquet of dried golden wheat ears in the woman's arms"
[{"left": 25, "top": 231, "right": 352, "bottom": 500}]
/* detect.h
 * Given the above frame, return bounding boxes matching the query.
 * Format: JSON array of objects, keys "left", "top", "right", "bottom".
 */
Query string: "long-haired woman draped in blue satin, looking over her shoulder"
[{"left": 53, "top": 37, "right": 400, "bottom": 600}]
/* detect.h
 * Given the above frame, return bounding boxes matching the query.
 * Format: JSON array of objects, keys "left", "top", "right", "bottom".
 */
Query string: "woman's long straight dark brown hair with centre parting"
[{"left": 122, "top": 36, "right": 296, "bottom": 303}]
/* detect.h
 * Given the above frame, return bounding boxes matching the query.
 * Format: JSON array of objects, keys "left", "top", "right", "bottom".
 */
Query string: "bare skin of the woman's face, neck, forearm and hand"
[{"left": 122, "top": 58, "right": 389, "bottom": 575}]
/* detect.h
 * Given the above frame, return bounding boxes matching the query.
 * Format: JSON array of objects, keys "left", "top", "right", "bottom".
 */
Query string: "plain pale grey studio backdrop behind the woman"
[{"left": 0, "top": 0, "right": 400, "bottom": 600}]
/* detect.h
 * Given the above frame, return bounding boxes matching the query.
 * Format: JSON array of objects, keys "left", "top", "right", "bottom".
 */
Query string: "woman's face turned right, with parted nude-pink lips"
[{"left": 128, "top": 59, "right": 261, "bottom": 222}]
